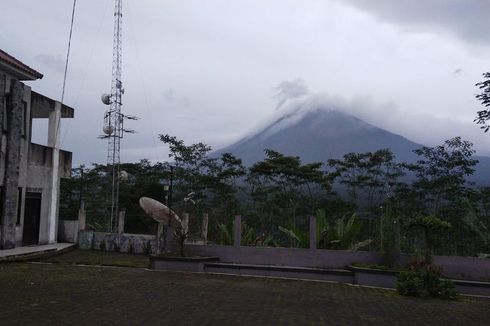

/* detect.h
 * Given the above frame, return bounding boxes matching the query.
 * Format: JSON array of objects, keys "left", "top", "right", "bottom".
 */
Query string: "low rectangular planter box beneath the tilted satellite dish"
[{"left": 150, "top": 255, "right": 219, "bottom": 272}]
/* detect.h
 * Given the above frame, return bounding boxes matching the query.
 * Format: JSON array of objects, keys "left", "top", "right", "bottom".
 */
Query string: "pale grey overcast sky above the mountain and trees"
[{"left": 0, "top": 0, "right": 490, "bottom": 165}]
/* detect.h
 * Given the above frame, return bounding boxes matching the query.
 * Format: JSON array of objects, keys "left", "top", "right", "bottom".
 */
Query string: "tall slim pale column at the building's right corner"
[{"left": 48, "top": 102, "right": 61, "bottom": 243}]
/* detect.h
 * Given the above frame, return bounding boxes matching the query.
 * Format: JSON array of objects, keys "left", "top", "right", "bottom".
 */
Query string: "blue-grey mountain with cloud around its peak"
[{"left": 217, "top": 107, "right": 421, "bottom": 165}]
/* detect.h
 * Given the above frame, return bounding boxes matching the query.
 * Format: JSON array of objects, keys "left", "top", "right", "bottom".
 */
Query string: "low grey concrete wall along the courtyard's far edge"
[{"left": 78, "top": 232, "right": 490, "bottom": 281}]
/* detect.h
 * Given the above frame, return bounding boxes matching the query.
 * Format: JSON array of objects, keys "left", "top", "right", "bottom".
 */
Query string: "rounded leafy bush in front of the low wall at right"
[{"left": 397, "top": 257, "right": 457, "bottom": 299}]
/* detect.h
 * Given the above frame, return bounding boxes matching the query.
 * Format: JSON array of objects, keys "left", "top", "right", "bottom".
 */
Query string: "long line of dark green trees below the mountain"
[{"left": 60, "top": 135, "right": 490, "bottom": 254}]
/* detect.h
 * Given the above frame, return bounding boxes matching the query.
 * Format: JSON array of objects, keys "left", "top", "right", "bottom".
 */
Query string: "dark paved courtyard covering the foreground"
[{"left": 0, "top": 252, "right": 490, "bottom": 325}]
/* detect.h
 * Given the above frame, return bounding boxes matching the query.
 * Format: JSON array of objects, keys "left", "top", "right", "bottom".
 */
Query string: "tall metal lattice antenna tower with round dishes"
[{"left": 99, "top": 0, "right": 136, "bottom": 231}]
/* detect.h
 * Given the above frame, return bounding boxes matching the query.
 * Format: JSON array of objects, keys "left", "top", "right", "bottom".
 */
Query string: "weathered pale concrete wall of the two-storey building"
[{"left": 0, "top": 63, "right": 73, "bottom": 248}]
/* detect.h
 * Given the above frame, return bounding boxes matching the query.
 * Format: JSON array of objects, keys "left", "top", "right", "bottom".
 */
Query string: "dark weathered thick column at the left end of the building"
[{"left": 0, "top": 79, "right": 24, "bottom": 249}]
